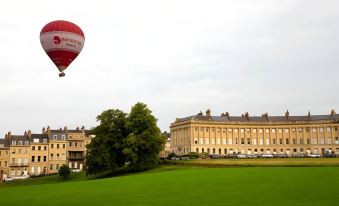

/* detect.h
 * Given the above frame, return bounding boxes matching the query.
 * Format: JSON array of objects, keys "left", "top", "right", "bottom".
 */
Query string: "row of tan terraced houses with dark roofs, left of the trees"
[{"left": 0, "top": 127, "right": 94, "bottom": 180}]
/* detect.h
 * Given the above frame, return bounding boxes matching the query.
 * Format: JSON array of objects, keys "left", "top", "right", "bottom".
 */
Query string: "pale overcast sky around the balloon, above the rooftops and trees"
[{"left": 0, "top": 0, "right": 339, "bottom": 137}]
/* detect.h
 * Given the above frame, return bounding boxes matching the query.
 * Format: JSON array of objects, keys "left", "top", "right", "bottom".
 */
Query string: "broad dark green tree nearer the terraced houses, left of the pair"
[{"left": 86, "top": 109, "right": 128, "bottom": 174}]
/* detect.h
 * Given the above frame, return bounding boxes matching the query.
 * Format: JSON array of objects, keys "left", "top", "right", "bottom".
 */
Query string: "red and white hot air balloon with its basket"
[{"left": 40, "top": 20, "right": 85, "bottom": 77}]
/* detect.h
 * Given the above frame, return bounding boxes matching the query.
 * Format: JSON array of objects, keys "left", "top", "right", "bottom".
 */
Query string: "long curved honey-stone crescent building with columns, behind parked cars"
[{"left": 171, "top": 110, "right": 339, "bottom": 156}]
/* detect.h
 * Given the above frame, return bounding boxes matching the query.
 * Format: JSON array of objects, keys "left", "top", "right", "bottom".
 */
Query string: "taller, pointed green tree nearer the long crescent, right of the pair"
[{"left": 123, "top": 102, "right": 165, "bottom": 171}]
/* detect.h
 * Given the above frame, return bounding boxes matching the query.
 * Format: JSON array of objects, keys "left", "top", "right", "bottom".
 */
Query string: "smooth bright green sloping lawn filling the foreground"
[{"left": 0, "top": 166, "right": 339, "bottom": 206}]
